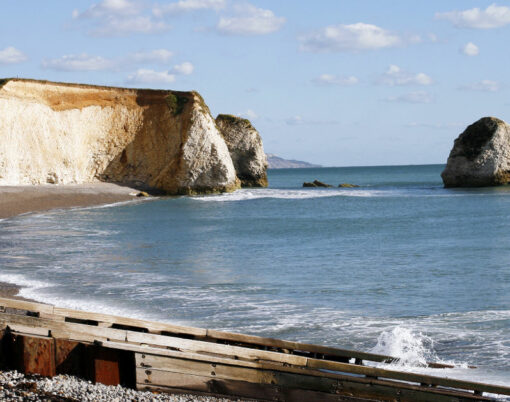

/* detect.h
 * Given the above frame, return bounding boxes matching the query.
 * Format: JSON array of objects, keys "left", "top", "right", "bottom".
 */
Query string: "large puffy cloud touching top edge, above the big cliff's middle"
[{"left": 72, "top": 0, "right": 170, "bottom": 36}]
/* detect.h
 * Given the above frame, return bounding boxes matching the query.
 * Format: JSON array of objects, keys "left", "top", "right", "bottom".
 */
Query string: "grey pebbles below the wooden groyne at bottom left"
[{"left": 0, "top": 371, "right": 245, "bottom": 402}]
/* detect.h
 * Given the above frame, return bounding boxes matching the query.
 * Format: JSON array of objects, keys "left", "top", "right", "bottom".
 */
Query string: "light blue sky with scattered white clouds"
[{"left": 0, "top": 0, "right": 510, "bottom": 166}]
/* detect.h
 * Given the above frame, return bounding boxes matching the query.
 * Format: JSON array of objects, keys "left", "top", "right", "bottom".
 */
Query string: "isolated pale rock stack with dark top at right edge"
[{"left": 441, "top": 117, "right": 510, "bottom": 187}]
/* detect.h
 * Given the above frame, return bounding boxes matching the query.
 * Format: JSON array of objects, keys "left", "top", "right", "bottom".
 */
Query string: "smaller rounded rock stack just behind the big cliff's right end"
[{"left": 216, "top": 114, "right": 267, "bottom": 187}]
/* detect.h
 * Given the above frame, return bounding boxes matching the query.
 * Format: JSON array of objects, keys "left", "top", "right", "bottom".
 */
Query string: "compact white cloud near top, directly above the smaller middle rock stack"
[{"left": 216, "top": 4, "right": 285, "bottom": 35}]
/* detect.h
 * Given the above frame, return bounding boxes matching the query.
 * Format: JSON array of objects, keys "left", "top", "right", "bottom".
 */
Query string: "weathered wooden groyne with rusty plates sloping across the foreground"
[{"left": 0, "top": 298, "right": 510, "bottom": 401}]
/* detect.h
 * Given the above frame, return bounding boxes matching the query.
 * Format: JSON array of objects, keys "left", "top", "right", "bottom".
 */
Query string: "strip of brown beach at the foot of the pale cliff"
[{"left": 0, "top": 183, "right": 139, "bottom": 219}]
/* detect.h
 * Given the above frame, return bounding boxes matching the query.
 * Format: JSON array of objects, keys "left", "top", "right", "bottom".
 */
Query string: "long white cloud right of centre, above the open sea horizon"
[{"left": 299, "top": 22, "right": 403, "bottom": 52}]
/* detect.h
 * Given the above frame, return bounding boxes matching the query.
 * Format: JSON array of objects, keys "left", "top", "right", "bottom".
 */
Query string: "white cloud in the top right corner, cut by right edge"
[{"left": 436, "top": 4, "right": 510, "bottom": 29}]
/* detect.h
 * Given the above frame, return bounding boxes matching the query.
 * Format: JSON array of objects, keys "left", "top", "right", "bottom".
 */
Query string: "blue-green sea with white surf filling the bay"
[{"left": 0, "top": 165, "right": 510, "bottom": 392}]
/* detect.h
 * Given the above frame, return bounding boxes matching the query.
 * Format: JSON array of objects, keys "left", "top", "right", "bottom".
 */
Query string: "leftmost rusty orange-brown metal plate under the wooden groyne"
[{"left": 11, "top": 335, "right": 55, "bottom": 377}]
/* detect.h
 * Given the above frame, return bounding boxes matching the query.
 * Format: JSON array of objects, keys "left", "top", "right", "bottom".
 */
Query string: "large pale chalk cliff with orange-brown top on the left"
[{"left": 0, "top": 79, "right": 239, "bottom": 194}]
